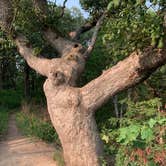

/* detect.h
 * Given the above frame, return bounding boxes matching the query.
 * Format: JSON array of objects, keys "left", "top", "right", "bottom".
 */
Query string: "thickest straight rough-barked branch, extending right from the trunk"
[{"left": 81, "top": 47, "right": 166, "bottom": 110}]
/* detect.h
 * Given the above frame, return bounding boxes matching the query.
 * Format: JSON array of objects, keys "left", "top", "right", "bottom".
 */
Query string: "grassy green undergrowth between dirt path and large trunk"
[{"left": 16, "top": 112, "right": 59, "bottom": 144}]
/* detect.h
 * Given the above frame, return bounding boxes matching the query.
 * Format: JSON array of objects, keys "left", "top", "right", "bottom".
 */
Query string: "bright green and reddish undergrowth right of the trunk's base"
[{"left": 101, "top": 98, "right": 166, "bottom": 166}]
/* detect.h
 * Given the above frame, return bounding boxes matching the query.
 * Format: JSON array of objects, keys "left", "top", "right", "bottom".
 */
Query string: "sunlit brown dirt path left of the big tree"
[{"left": 0, "top": 114, "right": 56, "bottom": 166}]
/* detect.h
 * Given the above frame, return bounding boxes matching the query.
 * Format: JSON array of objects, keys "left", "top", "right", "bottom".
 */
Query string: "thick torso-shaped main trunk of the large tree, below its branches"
[{"left": 44, "top": 80, "right": 103, "bottom": 166}]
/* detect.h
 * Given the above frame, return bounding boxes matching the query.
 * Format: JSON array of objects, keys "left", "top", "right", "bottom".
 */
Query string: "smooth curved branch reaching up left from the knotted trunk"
[{"left": 15, "top": 35, "right": 51, "bottom": 77}]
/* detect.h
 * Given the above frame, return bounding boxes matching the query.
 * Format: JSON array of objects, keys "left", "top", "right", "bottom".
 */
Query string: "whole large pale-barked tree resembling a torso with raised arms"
[{"left": 0, "top": 0, "right": 166, "bottom": 166}]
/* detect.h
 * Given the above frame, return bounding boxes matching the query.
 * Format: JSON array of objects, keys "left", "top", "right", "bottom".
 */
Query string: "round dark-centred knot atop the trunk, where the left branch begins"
[{"left": 48, "top": 71, "right": 66, "bottom": 86}]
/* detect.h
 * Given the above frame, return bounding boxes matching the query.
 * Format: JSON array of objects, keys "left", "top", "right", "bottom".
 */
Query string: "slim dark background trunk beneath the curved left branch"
[{"left": 24, "top": 62, "right": 30, "bottom": 99}]
